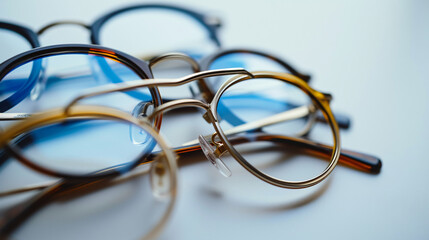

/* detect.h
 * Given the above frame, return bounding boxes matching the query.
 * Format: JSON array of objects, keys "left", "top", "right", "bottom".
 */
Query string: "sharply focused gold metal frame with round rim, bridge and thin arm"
[{"left": 64, "top": 68, "right": 340, "bottom": 188}]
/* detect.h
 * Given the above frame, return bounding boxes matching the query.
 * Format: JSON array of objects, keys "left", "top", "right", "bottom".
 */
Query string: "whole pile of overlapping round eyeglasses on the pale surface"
[{"left": 0, "top": 4, "right": 381, "bottom": 238}]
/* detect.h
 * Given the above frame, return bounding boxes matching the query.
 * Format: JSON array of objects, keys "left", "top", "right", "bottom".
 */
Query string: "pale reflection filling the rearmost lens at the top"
[{"left": 100, "top": 8, "right": 214, "bottom": 60}]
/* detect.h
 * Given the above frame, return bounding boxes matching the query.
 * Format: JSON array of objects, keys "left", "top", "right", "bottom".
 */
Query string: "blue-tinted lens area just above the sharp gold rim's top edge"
[{"left": 207, "top": 52, "right": 289, "bottom": 90}]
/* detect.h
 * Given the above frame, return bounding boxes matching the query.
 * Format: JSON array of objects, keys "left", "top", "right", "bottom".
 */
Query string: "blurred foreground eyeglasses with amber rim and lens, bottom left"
[{"left": 0, "top": 106, "right": 177, "bottom": 238}]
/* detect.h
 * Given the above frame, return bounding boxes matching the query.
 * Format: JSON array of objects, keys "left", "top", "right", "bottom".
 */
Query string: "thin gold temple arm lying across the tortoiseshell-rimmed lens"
[{"left": 64, "top": 68, "right": 253, "bottom": 113}]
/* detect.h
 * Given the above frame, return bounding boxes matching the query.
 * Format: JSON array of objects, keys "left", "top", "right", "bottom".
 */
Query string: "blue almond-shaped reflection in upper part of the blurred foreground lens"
[{"left": 13, "top": 119, "right": 156, "bottom": 175}]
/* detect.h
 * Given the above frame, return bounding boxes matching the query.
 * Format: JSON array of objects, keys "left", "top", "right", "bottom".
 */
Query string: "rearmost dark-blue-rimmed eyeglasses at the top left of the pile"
[{"left": 0, "top": 4, "right": 221, "bottom": 61}]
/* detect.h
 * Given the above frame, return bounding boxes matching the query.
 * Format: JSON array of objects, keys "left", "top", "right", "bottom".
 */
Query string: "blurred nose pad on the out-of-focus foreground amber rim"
[{"left": 150, "top": 154, "right": 171, "bottom": 200}]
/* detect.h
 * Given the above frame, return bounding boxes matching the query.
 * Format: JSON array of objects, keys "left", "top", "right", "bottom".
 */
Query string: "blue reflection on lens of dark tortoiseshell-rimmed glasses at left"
[{"left": 0, "top": 53, "right": 152, "bottom": 113}]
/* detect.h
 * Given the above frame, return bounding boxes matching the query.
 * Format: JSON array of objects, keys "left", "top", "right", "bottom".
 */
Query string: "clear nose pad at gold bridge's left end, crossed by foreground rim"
[{"left": 130, "top": 102, "right": 153, "bottom": 145}]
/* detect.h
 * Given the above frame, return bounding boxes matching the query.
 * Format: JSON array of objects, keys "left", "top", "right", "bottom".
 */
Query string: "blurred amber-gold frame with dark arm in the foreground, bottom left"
[{"left": 0, "top": 105, "right": 177, "bottom": 239}]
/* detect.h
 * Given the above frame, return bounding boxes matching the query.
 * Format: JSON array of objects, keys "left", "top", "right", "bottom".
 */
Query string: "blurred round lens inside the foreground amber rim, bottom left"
[{"left": 4, "top": 117, "right": 176, "bottom": 239}]
